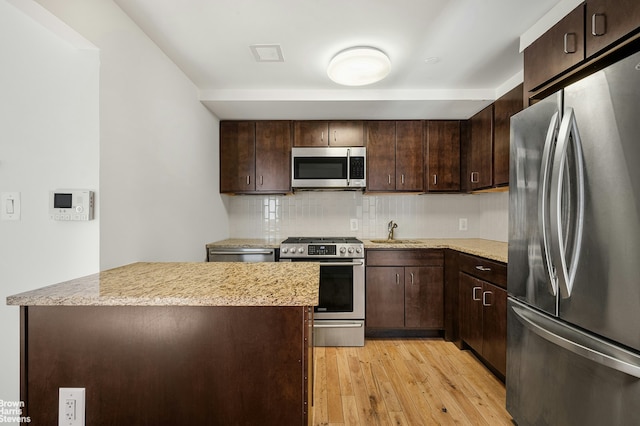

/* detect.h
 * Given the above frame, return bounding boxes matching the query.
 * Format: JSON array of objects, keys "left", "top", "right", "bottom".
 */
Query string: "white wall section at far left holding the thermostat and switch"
[{"left": 0, "top": 0, "right": 100, "bottom": 416}]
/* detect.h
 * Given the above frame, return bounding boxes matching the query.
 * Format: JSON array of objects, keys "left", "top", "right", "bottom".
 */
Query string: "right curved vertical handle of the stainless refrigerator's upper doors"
[{"left": 549, "top": 108, "right": 584, "bottom": 299}]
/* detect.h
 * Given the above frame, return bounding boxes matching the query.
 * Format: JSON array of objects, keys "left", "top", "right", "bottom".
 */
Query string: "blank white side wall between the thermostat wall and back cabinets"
[{"left": 34, "top": 0, "right": 228, "bottom": 269}]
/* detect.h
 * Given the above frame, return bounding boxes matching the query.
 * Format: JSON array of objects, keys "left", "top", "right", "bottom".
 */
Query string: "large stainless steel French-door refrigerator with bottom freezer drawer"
[{"left": 506, "top": 47, "right": 640, "bottom": 426}]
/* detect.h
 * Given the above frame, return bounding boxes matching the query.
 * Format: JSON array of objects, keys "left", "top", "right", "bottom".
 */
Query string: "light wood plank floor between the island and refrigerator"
[{"left": 312, "top": 338, "right": 513, "bottom": 426}]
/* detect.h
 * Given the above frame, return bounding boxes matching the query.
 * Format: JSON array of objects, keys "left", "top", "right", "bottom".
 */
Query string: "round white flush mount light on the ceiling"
[{"left": 327, "top": 47, "right": 391, "bottom": 86}]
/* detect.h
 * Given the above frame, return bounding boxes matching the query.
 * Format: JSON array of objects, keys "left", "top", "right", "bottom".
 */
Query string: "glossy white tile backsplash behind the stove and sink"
[{"left": 222, "top": 191, "right": 509, "bottom": 241}]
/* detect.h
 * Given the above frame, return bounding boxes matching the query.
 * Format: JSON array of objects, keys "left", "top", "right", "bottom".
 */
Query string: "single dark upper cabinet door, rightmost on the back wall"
[{"left": 424, "top": 121, "right": 460, "bottom": 192}]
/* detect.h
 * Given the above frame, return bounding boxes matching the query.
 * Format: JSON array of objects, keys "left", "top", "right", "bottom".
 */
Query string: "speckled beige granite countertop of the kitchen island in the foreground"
[{"left": 7, "top": 262, "right": 320, "bottom": 306}]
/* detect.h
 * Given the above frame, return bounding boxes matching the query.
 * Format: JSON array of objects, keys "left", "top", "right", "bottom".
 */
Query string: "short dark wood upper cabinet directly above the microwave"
[{"left": 293, "top": 121, "right": 364, "bottom": 146}]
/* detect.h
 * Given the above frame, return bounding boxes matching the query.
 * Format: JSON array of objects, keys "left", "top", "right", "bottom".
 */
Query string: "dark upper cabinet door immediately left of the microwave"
[{"left": 255, "top": 121, "right": 291, "bottom": 192}]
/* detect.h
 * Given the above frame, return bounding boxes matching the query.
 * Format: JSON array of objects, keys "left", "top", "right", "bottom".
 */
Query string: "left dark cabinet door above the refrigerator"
[{"left": 524, "top": 5, "right": 584, "bottom": 98}]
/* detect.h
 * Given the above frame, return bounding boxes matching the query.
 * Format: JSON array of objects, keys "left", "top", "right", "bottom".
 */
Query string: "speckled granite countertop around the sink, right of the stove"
[{"left": 362, "top": 238, "right": 509, "bottom": 263}]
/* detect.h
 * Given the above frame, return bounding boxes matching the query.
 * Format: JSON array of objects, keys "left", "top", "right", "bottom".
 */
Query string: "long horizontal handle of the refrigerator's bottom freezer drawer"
[{"left": 512, "top": 305, "right": 640, "bottom": 379}]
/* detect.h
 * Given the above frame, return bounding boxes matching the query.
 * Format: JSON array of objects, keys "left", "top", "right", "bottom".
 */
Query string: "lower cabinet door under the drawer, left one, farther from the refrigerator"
[{"left": 459, "top": 272, "right": 483, "bottom": 354}]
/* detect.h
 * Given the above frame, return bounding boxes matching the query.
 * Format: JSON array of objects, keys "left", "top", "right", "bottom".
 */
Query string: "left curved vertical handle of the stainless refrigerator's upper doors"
[{"left": 538, "top": 111, "right": 560, "bottom": 296}]
